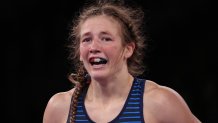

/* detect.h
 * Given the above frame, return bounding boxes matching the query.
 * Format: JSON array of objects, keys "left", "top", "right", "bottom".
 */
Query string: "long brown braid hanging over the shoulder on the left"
[{"left": 70, "top": 65, "right": 90, "bottom": 123}]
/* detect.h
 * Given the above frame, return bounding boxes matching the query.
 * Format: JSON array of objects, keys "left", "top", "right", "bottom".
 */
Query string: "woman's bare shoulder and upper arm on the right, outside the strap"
[{"left": 144, "top": 80, "right": 200, "bottom": 123}]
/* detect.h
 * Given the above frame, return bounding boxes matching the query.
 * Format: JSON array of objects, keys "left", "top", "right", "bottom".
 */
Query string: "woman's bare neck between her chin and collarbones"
[{"left": 87, "top": 73, "right": 133, "bottom": 104}]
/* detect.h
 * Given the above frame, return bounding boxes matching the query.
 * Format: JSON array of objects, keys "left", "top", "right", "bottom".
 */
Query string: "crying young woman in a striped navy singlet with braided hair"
[{"left": 43, "top": 2, "right": 200, "bottom": 123}]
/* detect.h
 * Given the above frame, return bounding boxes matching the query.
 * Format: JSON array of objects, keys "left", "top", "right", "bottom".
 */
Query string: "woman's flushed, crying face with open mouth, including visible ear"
[{"left": 79, "top": 15, "right": 134, "bottom": 79}]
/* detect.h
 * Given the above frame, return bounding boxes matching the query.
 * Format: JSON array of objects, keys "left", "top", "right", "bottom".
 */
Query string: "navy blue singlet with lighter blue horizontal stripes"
[{"left": 67, "top": 78, "right": 145, "bottom": 123}]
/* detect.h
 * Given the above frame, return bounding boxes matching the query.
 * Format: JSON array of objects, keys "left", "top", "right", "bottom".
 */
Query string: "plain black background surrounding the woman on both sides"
[{"left": 0, "top": 0, "right": 218, "bottom": 123}]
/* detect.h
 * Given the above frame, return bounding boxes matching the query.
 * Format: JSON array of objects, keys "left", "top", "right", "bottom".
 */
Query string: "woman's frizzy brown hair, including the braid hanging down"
[{"left": 69, "top": 0, "right": 145, "bottom": 122}]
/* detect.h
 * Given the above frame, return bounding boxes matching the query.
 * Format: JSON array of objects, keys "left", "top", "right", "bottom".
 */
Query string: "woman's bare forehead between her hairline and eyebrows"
[{"left": 80, "top": 15, "right": 121, "bottom": 36}]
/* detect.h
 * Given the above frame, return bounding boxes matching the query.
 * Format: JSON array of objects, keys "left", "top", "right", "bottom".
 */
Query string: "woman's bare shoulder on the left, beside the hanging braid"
[{"left": 43, "top": 89, "right": 74, "bottom": 123}]
